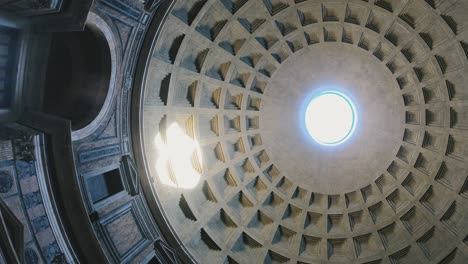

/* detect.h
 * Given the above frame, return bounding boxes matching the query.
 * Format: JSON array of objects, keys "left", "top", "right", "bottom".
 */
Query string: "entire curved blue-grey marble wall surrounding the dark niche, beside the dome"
[{"left": 0, "top": 0, "right": 188, "bottom": 263}]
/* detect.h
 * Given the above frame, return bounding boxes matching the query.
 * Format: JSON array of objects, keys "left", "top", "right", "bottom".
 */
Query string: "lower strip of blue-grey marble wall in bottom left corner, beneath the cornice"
[{"left": 0, "top": 126, "right": 63, "bottom": 264}]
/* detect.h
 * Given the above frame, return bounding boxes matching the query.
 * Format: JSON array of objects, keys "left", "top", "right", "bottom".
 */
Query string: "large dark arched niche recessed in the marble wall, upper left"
[{"left": 42, "top": 26, "right": 112, "bottom": 130}]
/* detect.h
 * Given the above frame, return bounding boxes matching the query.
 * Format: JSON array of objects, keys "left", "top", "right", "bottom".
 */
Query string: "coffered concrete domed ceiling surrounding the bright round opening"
[{"left": 137, "top": 0, "right": 468, "bottom": 263}]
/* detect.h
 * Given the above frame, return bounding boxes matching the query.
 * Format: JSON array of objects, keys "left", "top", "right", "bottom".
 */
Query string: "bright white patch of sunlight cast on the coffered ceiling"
[{"left": 155, "top": 123, "right": 202, "bottom": 189}]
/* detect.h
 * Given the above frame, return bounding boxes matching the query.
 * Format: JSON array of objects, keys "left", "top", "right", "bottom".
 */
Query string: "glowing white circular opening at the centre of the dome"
[{"left": 305, "top": 91, "right": 357, "bottom": 146}]
